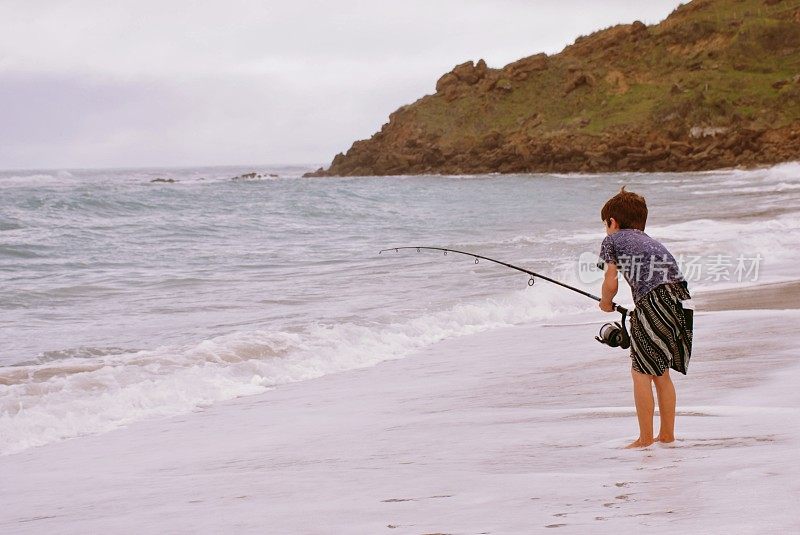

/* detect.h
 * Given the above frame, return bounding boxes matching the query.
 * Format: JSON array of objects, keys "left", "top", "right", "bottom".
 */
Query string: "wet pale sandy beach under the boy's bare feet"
[{"left": 0, "top": 285, "right": 800, "bottom": 534}]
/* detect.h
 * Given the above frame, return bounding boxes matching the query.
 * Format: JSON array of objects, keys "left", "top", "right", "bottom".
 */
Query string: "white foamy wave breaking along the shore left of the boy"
[{"left": 0, "top": 283, "right": 590, "bottom": 454}]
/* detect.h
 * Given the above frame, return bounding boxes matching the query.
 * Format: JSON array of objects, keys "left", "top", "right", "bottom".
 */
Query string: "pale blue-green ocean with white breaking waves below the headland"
[{"left": 0, "top": 163, "right": 800, "bottom": 455}]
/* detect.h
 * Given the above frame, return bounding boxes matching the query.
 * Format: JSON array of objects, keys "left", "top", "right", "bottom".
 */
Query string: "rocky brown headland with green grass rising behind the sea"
[{"left": 309, "top": 0, "right": 800, "bottom": 176}]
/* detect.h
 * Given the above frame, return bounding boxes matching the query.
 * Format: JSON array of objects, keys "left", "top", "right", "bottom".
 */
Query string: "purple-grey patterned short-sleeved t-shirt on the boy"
[{"left": 600, "top": 228, "right": 684, "bottom": 303}]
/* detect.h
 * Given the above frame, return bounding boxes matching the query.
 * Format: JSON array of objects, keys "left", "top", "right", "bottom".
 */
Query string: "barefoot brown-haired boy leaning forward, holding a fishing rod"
[{"left": 600, "top": 186, "right": 692, "bottom": 448}]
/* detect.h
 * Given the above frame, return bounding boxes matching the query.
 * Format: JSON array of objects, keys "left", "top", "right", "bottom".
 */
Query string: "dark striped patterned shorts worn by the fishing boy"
[{"left": 630, "top": 281, "right": 694, "bottom": 375}]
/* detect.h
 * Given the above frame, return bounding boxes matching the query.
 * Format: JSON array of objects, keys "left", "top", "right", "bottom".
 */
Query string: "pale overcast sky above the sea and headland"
[{"left": 0, "top": 0, "right": 679, "bottom": 169}]
